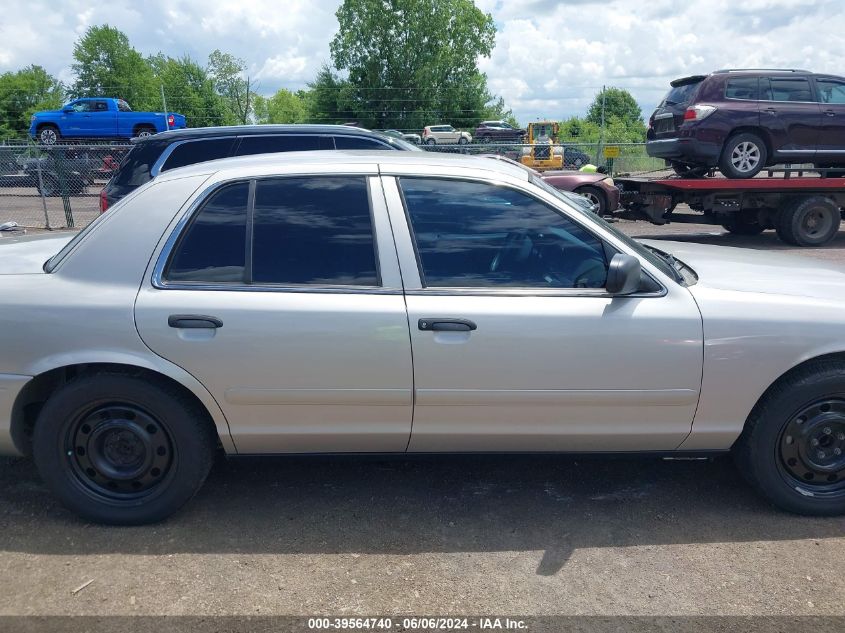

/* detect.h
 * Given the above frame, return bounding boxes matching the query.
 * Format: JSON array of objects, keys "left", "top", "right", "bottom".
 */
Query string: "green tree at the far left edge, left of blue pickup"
[{"left": 0, "top": 65, "right": 64, "bottom": 138}]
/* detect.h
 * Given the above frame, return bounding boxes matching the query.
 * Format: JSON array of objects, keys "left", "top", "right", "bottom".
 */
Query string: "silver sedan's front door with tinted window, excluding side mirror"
[{"left": 385, "top": 176, "right": 703, "bottom": 451}]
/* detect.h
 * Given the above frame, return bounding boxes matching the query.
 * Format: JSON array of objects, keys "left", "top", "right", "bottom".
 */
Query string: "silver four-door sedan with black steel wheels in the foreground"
[{"left": 0, "top": 152, "right": 845, "bottom": 524}]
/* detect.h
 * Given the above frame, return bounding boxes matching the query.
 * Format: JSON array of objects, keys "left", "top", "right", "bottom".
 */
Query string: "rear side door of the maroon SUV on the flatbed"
[{"left": 760, "top": 77, "right": 822, "bottom": 161}]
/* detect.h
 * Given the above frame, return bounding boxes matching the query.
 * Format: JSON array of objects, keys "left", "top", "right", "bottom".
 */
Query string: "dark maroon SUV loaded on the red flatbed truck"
[{"left": 646, "top": 70, "right": 845, "bottom": 178}]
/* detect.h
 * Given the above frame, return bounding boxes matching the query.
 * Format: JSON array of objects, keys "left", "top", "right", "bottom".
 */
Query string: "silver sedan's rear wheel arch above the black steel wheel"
[{"left": 10, "top": 359, "right": 237, "bottom": 455}]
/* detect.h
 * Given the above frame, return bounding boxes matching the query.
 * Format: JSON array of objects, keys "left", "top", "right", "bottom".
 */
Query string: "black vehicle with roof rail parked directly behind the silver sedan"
[{"left": 100, "top": 124, "right": 422, "bottom": 213}]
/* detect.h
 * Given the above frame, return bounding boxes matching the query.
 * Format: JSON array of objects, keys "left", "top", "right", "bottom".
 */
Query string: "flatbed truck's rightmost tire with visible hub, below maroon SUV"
[{"left": 775, "top": 196, "right": 842, "bottom": 246}]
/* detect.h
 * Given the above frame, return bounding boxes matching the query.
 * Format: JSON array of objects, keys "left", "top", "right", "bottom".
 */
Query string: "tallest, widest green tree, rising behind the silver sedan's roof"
[{"left": 328, "top": 0, "right": 496, "bottom": 129}]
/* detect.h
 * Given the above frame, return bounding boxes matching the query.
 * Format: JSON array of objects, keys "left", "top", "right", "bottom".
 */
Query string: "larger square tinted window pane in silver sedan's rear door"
[{"left": 252, "top": 176, "right": 379, "bottom": 286}]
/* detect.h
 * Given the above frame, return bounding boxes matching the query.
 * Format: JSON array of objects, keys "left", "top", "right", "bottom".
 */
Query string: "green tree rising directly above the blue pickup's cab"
[{"left": 70, "top": 24, "right": 161, "bottom": 110}]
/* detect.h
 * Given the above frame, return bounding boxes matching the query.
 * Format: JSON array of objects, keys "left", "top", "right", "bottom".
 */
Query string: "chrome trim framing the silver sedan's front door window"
[{"left": 390, "top": 174, "right": 669, "bottom": 298}]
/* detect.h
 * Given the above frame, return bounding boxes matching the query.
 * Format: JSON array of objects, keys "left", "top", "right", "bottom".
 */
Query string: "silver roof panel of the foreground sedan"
[{"left": 156, "top": 150, "right": 530, "bottom": 181}]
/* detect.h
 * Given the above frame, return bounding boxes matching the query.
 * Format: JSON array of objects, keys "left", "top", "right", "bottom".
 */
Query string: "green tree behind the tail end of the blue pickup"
[{"left": 149, "top": 53, "right": 227, "bottom": 127}]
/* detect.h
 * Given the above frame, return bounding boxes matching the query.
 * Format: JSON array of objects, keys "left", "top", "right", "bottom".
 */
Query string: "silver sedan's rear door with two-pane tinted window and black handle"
[{"left": 135, "top": 174, "right": 412, "bottom": 453}]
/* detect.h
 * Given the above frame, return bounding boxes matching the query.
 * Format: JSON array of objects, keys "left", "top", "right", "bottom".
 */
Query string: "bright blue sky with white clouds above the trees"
[{"left": 0, "top": 0, "right": 845, "bottom": 123}]
